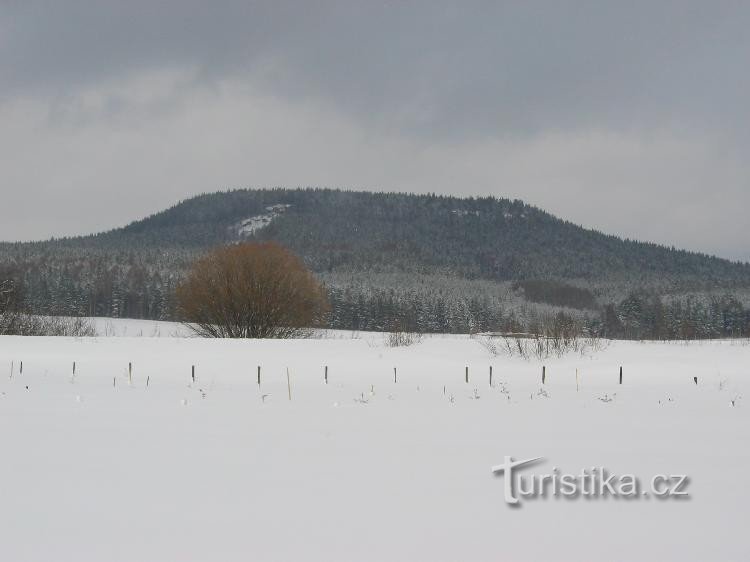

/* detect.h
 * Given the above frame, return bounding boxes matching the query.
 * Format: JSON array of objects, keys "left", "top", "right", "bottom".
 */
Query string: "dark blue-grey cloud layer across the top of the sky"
[{"left": 0, "top": 0, "right": 750, "bottom": 137}]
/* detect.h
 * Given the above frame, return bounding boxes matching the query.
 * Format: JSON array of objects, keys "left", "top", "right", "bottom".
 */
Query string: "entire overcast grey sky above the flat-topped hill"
[{"left": 0, "top": 0, "right": 750, "bottom": 261}]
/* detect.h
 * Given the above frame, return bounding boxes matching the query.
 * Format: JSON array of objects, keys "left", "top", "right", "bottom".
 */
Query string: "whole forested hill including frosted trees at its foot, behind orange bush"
[{"left": 0, "top": 189, "right": 750, "bottom": 337}]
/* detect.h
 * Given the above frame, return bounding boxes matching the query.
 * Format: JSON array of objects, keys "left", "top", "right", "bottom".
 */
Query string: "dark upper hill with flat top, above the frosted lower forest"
[{"left": 11, "top": 189, "right": 750, "bottom": 287}]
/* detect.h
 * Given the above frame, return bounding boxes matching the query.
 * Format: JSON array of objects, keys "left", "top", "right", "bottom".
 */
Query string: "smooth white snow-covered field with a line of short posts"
[{"left": 0, "top": 321, "right": 750, "bottom": 562}]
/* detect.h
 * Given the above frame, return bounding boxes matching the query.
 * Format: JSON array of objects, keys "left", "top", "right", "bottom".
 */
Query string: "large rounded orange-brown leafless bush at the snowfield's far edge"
[{"left": 176, "top": 242, "right": 328, "bottom": 338}]
